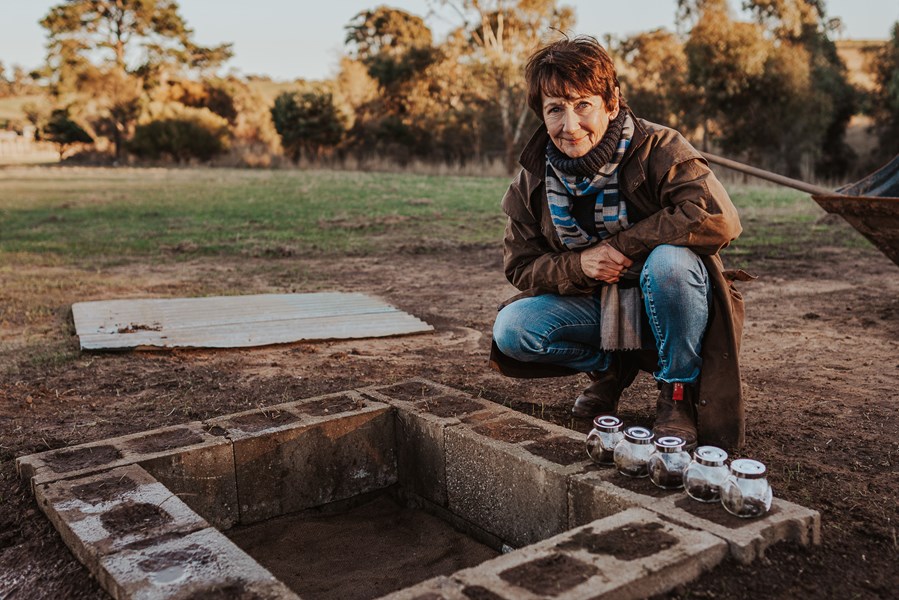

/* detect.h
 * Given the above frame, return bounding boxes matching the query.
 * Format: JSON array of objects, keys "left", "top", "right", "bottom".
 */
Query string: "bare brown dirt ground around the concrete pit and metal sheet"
[{"left": 0, "top": 240, "right": 899, "bottom": 600}]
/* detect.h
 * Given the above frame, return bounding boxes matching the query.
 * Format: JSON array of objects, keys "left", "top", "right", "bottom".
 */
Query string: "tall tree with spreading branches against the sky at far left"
[{"left": 41, "top": 0, "right": 231, "bottom": 158}]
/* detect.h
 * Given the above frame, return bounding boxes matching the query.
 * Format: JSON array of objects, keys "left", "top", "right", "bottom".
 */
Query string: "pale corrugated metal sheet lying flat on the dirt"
[{"left": 72, "top": 292, "right": 433, "bottom": 350}]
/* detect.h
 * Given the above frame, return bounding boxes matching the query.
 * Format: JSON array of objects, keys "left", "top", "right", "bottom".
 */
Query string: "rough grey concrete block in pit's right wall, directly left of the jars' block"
[{"left": 445, "top": 413, "right": 591, "bottom": 547}]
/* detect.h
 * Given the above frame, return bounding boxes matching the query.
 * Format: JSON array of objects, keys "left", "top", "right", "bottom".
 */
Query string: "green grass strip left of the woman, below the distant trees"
[{"left": 0, "top": 169, "right": 508, "bottom": 263}]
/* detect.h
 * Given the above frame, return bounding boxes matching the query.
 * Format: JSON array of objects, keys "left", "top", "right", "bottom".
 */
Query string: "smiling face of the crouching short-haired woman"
[{"left": 543, "top": 95, "right": 618, "bottom": 158}]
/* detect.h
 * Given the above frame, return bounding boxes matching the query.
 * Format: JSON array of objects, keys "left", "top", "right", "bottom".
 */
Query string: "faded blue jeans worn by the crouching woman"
[{"left": 493, "top": 245, "right": 712, "bottom": 383}]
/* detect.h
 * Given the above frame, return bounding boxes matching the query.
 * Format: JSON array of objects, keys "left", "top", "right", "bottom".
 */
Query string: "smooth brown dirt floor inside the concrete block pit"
[{"left": 225, "top": 493, "right": 499, "bottom": 600}]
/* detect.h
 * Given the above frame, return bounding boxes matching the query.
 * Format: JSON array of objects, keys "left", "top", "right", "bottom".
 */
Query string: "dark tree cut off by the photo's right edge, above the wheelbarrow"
[{"left": 871, "top": 22, "right": 899, "bottom": 160}]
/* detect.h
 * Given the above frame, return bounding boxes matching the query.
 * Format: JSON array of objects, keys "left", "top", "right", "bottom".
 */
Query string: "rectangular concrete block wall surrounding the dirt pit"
[{"left": 17, "top": 379, "right": 820, "bottom": 600}]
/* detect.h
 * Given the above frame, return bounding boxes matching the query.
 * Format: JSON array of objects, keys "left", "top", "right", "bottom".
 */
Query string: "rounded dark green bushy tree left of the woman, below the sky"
[{"left": 271, "top": 91, "right": 344, "bottom": 162}]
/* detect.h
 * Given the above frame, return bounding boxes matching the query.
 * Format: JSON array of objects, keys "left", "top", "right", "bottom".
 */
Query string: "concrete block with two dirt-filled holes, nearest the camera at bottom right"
[{"left": 452, "top": 509, "right": 727, "bottom": 600}]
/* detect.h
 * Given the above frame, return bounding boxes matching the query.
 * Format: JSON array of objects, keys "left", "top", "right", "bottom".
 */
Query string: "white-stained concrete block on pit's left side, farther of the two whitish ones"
[{"left": 35, "top": 465, "right": 209, "bottom": 575}]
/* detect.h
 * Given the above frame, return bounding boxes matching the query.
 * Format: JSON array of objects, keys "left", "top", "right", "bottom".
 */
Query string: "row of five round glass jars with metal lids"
[{"left": 587, "top": 416, "right": 773, "bottom": 517}]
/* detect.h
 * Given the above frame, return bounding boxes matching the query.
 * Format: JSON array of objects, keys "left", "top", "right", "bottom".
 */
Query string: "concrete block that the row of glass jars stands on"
[{"left": 570, "top": 469, "right": 821, "bottom": 564}]
